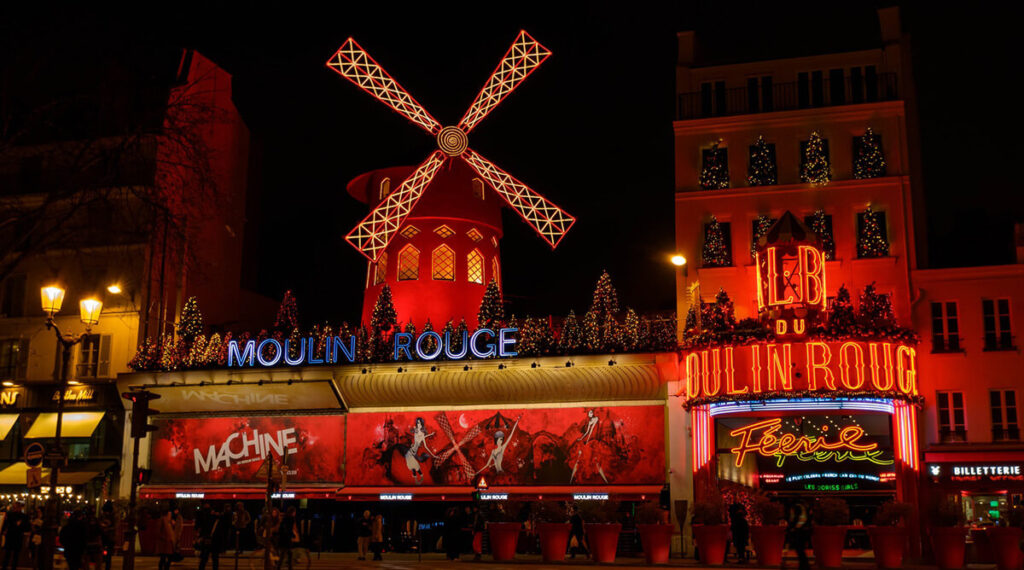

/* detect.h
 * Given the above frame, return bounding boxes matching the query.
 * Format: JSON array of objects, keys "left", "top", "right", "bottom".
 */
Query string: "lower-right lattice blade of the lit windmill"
[{"left": 462, "top": 148, "right": 575, "bottom": 249}]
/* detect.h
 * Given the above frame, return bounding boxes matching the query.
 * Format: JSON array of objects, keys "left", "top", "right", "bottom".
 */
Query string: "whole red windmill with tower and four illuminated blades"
[{"left": 327, "top": 32, "right": 575, "bottom": 330}]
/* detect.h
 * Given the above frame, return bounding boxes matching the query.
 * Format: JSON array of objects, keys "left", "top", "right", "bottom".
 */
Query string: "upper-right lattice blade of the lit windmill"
[{"left": 459, "top": 31, "right": 551, "bottom": 133}]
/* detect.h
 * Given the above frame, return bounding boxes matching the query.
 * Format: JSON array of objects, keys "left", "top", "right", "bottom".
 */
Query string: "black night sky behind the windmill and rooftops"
[{"left": 8, "top": 1, "right": 1024, "bottom": 321}]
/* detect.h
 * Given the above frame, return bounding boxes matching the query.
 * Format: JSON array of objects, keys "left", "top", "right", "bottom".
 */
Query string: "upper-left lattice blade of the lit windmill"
[{"left": 327, "top": 38, "right": 441, "bottom": 135}]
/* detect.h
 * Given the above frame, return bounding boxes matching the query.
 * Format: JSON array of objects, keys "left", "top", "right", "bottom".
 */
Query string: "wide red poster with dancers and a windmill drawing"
[{"left": 346, "top": 405, "right": 665, "bottom": 486}]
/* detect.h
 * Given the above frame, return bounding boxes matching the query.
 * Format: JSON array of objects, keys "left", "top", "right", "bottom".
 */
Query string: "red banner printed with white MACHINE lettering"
[{"left": 150, "top": 415, "right": 345, "bottom": 484}]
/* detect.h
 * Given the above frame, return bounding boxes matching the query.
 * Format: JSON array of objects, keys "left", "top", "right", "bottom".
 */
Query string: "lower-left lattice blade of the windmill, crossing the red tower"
[{"left": 345, "top": 150, "right": 445, "bottom": 261}]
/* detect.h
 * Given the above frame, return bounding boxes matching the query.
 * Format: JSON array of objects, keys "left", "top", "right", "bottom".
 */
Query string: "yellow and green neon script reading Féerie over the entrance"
[{"left": 729, "top": 418, "right": 893, "bottom": 467}]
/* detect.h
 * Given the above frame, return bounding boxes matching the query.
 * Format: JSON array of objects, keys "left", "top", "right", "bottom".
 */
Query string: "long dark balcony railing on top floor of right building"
[{"left": 676, "top": 74, "right": 899, "bottom": 121}]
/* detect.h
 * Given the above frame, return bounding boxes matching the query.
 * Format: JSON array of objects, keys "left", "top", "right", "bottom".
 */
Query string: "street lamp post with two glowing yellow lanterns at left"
[{"left": 39, "top": 286, "right": 103, "bottom": 570}]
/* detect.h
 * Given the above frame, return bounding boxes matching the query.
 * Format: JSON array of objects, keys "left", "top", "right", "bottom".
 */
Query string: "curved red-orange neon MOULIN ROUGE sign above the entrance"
[{"left": 683, "top": 341, "right": 918, "bottom": 401}]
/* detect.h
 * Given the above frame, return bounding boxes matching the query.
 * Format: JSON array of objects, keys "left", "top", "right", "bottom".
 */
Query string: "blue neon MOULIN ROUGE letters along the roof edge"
[{"left": 227, "top": 328, "right": 519, "bottom": 367}]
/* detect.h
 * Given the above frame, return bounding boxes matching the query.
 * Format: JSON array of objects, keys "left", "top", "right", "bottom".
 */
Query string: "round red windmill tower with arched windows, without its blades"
[{"left": 348, "top": 161, "right": 503, "bottom": 331}]
